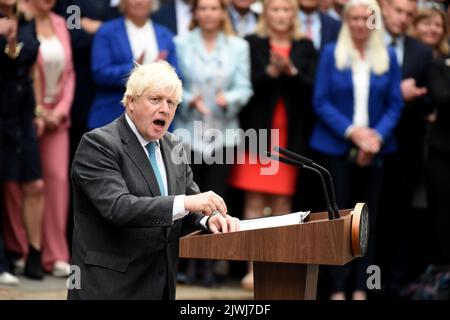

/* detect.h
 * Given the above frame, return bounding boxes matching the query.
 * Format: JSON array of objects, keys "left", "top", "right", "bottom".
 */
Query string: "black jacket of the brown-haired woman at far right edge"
[{"left": 429, "top": 55, "right": 450, "bottom": 152}]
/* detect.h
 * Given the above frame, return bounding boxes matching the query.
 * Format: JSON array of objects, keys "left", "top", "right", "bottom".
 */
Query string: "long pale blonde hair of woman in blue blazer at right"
[{"left": 334, "top": 0, "right": 390, "bottom": 75}]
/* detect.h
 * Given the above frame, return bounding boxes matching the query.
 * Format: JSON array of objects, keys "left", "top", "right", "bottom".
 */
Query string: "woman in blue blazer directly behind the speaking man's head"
[{"left": 88, "top": 0, "right": 177, "bottom": 129}]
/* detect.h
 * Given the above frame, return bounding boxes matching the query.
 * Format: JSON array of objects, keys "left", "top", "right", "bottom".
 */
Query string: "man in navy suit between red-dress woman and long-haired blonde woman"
[{"left": 298, "top": 0, "right": 341, "bottom": 51}]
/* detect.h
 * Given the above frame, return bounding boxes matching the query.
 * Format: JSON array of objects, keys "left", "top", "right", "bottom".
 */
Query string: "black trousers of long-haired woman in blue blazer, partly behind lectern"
[{"left": 321, "top": 155, "right": 383, "bottom": 293}]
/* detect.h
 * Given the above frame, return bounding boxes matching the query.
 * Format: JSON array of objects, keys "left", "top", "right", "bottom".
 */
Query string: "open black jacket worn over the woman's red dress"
[{"left": 241, "top": 35, "right": 317, "bottom": 152}]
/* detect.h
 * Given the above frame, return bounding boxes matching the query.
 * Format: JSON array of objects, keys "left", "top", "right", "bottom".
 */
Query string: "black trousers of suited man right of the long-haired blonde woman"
[{"left": 376, "top": 140, "right": 424, "bottom": 296}]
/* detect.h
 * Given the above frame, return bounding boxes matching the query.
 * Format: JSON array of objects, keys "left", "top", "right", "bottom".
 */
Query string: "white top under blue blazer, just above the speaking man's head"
[{"left": 125, "top": 19, "right": 159, "bottom": 64}]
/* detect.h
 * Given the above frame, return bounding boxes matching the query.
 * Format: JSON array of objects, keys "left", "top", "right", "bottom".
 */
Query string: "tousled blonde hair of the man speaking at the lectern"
[{"left": 122, "top": 60, "right": 183, "bottom": 107}]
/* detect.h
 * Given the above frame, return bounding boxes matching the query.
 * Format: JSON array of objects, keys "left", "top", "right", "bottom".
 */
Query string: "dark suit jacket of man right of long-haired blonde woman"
[{"left": 396, "top": 36, "right": 433, "bottom": 142}]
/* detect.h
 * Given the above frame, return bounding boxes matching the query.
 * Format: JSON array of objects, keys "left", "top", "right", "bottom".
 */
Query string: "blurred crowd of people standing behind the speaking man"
[{"left": 0, "top": 0, "right": 450, "bottom": 300}]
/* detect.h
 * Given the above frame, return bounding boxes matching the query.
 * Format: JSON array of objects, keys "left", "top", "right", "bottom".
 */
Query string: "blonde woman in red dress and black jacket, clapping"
[{"left": 230, "top": 0, "right": 317, "bottom": 289}]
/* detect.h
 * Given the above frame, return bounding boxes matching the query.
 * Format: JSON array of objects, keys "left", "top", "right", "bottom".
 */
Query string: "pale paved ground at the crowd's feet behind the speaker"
[{"left": 0, "top": 276, "right": 253, "bottom": 300}]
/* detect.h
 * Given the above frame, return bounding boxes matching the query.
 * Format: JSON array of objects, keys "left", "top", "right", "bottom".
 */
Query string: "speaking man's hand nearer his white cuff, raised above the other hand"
[{"left": 184, "top": 191, "right": 228, "bottom": 217}]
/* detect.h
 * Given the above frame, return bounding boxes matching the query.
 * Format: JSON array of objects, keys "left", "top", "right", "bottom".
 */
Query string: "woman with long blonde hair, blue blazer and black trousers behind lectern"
[{"left": 310, "top": 0, "right": 403, "bottom": 299}]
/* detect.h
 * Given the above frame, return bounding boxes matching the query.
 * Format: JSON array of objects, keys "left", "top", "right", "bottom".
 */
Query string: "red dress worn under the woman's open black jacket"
[{"left": 229, "top": 100, "right": 298, "bottom": 196}]
